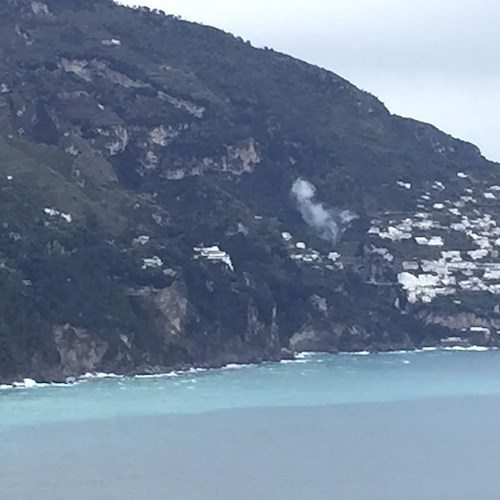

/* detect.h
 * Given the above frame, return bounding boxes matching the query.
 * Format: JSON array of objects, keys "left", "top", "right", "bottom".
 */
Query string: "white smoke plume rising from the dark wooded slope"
[{"left": 292, "top": 178, "right": 358, "bottom": 244}]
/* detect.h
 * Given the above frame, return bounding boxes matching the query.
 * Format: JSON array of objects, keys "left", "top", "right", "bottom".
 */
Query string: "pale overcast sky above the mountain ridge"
[{"left": 120, "top": 0, "right": 500, "bottom": 162}]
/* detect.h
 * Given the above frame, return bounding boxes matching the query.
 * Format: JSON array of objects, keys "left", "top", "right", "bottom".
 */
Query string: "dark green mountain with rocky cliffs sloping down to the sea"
[{"left": 0, "top": 0, "right": 500, "bottom": 381}]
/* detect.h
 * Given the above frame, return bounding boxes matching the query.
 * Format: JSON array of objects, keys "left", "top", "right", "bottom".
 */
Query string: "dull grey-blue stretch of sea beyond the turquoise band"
[{"left": 0, "top": 396, "right": 500, "bottom": 500}]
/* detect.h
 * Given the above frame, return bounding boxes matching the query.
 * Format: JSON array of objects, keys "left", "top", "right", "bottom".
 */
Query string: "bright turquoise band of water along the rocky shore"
[{"left": 0, "top": 350, "right": 500, "bottom": 430}]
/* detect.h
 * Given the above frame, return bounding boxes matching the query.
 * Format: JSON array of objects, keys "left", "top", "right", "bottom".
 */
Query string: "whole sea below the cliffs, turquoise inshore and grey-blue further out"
[{"left": 0, "top": 347, "right": 500, "bottom": 500}]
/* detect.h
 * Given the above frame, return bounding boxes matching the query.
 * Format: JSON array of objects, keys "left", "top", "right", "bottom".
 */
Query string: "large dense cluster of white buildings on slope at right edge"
[{"left": 369, "top": 176, "right": 500, "bottom": 303}]
